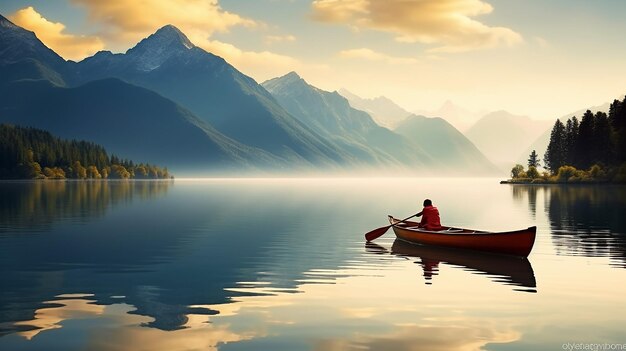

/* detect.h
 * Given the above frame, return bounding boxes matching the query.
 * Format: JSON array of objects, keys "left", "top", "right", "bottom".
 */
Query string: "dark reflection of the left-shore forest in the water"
[{"left": 0, "top": 180, "right": 173, "bottom": 235}]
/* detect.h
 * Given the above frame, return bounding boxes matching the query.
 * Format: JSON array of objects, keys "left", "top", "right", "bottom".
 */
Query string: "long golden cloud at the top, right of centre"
[{"left": 312, "top": 0, "right": 523, "bottom": 53}]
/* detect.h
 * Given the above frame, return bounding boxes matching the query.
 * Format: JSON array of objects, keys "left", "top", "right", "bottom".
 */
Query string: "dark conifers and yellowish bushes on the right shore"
[{"left": 501, "top": 97, "right": 626, "bottom": 184}]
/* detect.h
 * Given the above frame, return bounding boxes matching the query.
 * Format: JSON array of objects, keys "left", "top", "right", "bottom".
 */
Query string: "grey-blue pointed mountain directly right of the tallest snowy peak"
[{"left": 263, "top": 72, "right": 430, "bottom": 166}]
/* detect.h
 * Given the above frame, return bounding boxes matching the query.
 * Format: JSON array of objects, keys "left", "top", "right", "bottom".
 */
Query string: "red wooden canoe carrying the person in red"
[{"left": 389, "top": 216, "right": 537, "bottom": 257}]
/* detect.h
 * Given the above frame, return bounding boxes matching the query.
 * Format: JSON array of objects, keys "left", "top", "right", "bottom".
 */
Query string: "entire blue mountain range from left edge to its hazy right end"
[{"left": 0, "top": 16, "right": 498, "bottom": 174}]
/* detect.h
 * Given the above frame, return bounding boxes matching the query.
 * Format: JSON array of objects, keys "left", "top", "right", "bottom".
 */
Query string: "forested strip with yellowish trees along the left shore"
[{"left": 0, "top": 124, "right": 173, "bottom": 179}]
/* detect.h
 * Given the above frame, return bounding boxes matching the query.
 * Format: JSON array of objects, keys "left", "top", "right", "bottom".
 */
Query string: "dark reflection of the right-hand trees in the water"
[{"left": 512, "top": 185, "right": 626, "bottom": 268}]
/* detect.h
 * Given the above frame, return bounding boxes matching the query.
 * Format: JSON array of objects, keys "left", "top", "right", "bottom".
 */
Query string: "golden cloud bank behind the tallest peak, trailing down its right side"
[{"left": 71, "top": 0, "right": 299, "bottom": 77}]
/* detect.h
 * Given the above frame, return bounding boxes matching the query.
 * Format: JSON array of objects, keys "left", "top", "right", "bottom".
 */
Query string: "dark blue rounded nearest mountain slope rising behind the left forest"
[{"left": 0, "top": 79, "right": 284, "bottom": 172}]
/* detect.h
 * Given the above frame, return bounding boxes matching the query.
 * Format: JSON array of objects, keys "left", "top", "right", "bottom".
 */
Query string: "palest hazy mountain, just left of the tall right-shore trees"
[{"left": 465, "top": 111, "right": 550, "bottom": 170}]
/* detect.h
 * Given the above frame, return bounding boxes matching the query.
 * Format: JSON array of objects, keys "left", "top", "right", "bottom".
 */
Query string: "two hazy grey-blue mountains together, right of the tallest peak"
[{"left": 262, "top": 72, "right": 496, "bottom": 174}]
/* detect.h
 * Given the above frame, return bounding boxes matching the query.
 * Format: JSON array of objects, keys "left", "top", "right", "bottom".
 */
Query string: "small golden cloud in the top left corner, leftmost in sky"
[{"left": 9, "top": 6, "right": 104, "bottom": 60}]
